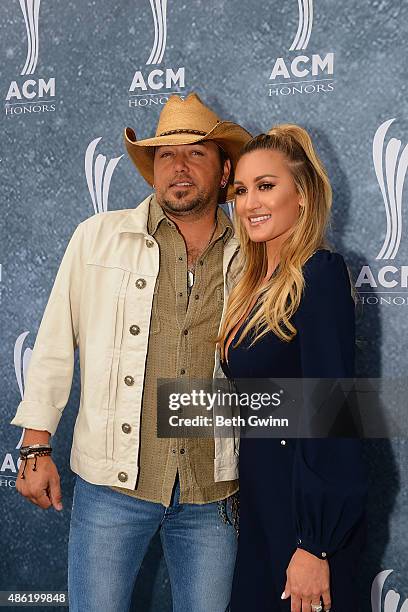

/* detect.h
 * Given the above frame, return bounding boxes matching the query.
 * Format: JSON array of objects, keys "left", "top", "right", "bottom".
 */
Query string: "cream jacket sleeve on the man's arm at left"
[{"left": 10, "top": 222, "right": 84, "bottom": 435}]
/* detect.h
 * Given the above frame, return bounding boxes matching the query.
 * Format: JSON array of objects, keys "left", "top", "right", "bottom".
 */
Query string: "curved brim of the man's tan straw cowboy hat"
[{"left": 124, "top": 121, "right": 252, "bottom": 200}]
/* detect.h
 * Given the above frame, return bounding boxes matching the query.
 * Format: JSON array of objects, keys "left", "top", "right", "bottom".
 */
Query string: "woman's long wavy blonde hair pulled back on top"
[{"left": 217, "top": 124, "right": 332, "bottom": 359}]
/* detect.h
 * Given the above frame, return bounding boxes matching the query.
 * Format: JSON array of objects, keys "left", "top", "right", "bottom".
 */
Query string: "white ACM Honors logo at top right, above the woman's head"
[{"left": 268, "top": 0, "right": 334, "bottom": 96}]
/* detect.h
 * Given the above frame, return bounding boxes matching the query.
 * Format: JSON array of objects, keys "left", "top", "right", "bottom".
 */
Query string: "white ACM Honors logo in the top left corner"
[{"left": 4, "top": 0, "right": 55, "bottom": 116}]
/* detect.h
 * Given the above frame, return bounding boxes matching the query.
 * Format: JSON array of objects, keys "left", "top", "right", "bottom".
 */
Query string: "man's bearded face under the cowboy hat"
[{"left": 154, "top": 141, "right": 230, "bottom": 217}]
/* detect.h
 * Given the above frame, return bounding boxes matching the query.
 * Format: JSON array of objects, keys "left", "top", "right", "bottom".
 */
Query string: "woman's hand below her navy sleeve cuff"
[{"left": 282, "top": 548, "right": 331, "bottom": 612}]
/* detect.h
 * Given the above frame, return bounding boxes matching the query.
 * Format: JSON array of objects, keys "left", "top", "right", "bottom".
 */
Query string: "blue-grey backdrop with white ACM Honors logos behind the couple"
[{"left": 0, "top": 0, "right": 408, "bottom": 612}]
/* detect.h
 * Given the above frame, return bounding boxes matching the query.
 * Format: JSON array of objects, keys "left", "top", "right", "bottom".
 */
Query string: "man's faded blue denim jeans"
[{"left": 68, "top": 475, "right": 237, "bottom": 612}]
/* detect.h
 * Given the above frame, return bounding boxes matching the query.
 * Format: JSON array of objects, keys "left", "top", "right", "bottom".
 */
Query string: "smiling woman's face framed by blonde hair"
[{"left": 234, "top": 149, "right": 301, "bottom": 242}]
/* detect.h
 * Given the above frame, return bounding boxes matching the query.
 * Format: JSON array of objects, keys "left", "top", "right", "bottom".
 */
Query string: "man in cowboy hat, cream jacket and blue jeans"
[{"left": 11, "top": 94, "right": 250, "bottom": 612}]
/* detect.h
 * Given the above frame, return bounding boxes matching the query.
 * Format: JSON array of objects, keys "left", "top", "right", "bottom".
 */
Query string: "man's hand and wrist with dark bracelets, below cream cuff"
[{"left": 16, "top": 429, "right": 63, "bottom": 510}]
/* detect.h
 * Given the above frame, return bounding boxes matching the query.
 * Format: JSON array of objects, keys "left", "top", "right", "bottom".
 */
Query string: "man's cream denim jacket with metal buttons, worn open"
[{"left": 10, "top": 196, "right": 238, "bottom": 489}]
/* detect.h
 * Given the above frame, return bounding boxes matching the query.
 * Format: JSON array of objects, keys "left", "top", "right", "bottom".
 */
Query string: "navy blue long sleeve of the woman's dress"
[{"left": 293, "top": 251, "right": 367, "bottom": 558}]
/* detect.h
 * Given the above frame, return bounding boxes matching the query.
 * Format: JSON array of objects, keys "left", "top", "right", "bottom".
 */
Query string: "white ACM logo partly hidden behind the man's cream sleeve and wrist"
[{"left": 0, "top": 331, "right": 32, "bottom": 488}]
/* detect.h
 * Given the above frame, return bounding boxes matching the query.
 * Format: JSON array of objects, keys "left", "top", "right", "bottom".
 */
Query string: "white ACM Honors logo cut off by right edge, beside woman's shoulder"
[{"left": 356, "top": 118, "right": 408, "bottom": 305}]
